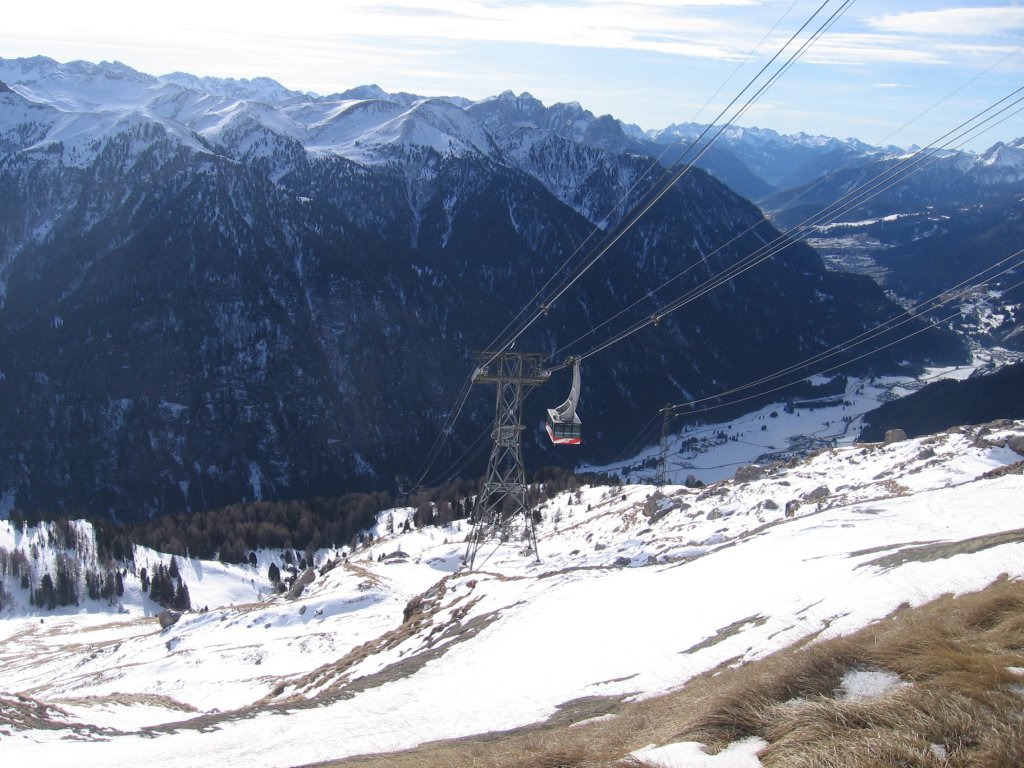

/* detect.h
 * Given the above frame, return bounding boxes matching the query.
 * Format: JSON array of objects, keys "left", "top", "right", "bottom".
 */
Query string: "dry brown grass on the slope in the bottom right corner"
[{"left": 301, "top": 579, "right": 1024, "bottom": 768}]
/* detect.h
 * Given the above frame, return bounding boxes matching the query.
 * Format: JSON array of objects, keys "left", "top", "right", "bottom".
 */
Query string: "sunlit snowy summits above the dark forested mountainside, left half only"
[{"left": 0, "top": 57, "right": 494, "bottom": 165}]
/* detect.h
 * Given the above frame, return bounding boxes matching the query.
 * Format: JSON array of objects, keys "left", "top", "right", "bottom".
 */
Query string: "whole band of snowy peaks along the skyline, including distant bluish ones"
[{"left": 0, "top": 56, "right": 1021, "bottom": 199}]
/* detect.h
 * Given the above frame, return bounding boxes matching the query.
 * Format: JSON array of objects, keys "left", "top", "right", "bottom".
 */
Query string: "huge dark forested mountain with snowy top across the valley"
[{"left": 0, "top": 57, "right": 964, "bottom": 519}]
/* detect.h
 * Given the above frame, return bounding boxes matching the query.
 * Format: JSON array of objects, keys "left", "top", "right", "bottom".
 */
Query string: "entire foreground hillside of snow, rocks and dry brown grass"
[{"left": 0, "top": 422, "right": 1024, "bottom": 768}]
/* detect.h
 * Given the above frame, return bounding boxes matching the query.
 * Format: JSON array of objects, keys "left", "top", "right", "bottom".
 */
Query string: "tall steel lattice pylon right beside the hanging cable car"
[{"left": 465, "top": 351, "right": 551, "bottom": 570}]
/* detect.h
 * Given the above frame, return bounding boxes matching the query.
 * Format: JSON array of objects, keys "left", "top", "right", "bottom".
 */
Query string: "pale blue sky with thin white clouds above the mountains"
[{"left": 0, "top": 0, "right": 1024, "bottom": 150}]
